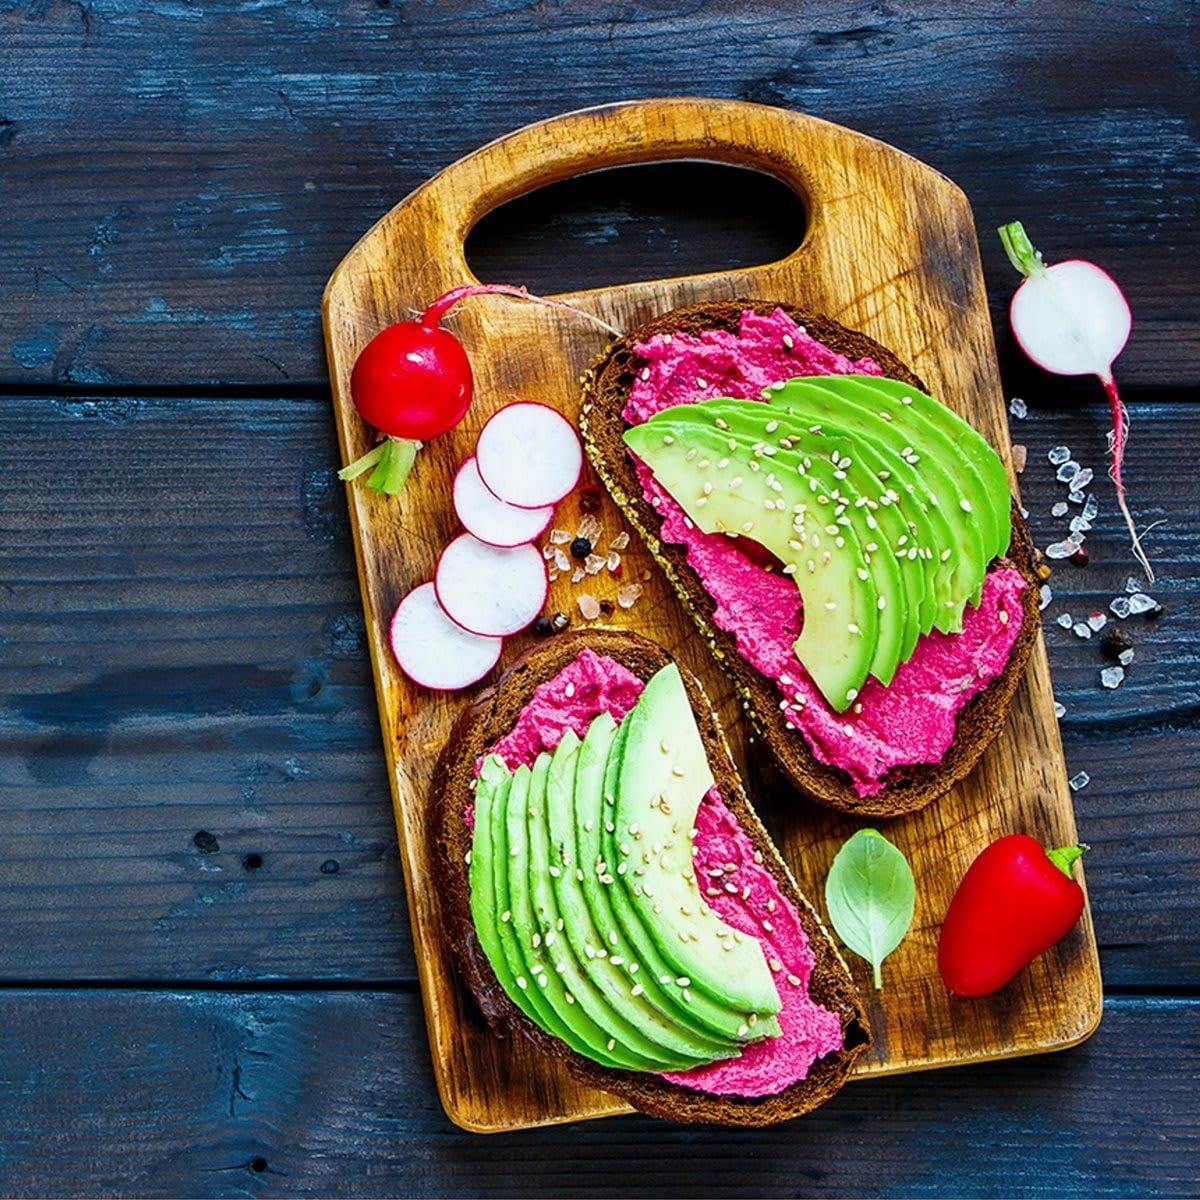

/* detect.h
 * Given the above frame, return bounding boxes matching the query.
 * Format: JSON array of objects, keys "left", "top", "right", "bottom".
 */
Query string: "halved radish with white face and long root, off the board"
[{"left": 998, "top": 221, "right": 1154, "bottom": 583}]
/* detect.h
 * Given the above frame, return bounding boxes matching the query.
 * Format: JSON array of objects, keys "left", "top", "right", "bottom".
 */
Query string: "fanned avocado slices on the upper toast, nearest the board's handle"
[{"left": 624, "top": 376, "right": 1012, "bottom": 712}]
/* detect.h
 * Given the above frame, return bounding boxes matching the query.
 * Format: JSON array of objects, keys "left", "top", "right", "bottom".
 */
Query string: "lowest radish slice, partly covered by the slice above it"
[{"left": 389, "top": 583, "right": 504, "bottom": 691}]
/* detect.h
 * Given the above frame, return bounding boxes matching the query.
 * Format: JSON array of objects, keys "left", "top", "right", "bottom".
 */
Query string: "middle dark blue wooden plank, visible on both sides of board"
[{"left": 0, "top": 393, "right": 1200, "bottom": 985}]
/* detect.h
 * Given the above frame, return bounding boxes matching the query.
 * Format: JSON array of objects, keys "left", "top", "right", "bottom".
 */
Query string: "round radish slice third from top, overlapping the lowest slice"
[{"left": 433, "top": 533, "right": 550, "bottom": 637}]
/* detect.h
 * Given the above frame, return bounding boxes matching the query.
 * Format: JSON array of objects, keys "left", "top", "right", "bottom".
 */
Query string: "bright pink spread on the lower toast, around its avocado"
[{"left": 490, "top": 649, "right": 842, "bottom": 1096}]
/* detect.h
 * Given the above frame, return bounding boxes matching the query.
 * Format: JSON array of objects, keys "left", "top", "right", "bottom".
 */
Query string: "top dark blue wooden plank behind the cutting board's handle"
[{"left": 0, "top": 0, "right": 1200, "bottom": 386}]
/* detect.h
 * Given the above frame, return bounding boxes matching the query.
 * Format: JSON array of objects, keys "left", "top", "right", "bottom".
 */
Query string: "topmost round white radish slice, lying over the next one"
[{"left": 475, "top": 401, "right": 583, "bottom": 509}]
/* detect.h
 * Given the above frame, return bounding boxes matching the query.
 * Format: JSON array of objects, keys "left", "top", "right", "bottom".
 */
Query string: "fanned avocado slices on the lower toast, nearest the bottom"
[{"left": 468, "top": 666, "right": 782, "bottom": 1072}]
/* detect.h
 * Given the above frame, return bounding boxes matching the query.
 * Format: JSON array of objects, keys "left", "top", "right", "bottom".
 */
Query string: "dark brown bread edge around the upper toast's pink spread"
[{"left": 580, "top": 300, "right": 1040, "bottom": 818}]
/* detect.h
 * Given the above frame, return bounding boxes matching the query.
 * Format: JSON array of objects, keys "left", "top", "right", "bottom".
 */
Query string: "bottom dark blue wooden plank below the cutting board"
[{"left": 0, "top": 990, "right": 1200, "bottom": 1198}]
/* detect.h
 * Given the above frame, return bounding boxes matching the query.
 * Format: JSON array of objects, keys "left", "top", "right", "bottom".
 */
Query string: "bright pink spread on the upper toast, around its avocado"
[{"left": 624, "top": 308, "right": 1025, "bottom": 797}]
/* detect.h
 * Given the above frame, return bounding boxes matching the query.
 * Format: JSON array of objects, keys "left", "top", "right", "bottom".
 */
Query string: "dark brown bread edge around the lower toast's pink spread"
[{"left": 434, "top": 629, "right": 870, "bottom": 1126}]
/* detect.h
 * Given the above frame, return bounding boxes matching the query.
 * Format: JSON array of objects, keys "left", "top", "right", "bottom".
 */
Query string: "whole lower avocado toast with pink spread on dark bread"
[{"left": 436, "top": 630, "right": 870, "bottom": 1126}]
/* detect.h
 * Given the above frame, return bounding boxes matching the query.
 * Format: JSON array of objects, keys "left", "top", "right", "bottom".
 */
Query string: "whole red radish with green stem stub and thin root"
[{"left": 337, "top": 283, "right": 619, "bottom": 496}]
